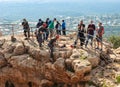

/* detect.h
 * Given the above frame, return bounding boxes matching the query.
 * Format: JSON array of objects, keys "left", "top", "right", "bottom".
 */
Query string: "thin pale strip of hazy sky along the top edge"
[{"left": 0, "top": 0, "right": 120, "bottom": 2}]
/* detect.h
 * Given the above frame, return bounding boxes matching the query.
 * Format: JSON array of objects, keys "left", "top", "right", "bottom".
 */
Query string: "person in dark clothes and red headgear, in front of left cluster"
[{"left": 37, "top": 25, "right": 45, "bottom": 48}]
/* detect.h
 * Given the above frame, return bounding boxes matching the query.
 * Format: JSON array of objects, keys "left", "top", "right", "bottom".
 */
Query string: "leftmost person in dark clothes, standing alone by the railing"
[{"left": 22, "top": 19, "right": 30, "bottom": 40}]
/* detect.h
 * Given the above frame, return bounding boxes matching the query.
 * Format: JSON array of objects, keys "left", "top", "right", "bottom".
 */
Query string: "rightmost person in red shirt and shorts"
[{"left": 96, "top": 22, "right": 104, "bottom": 51}]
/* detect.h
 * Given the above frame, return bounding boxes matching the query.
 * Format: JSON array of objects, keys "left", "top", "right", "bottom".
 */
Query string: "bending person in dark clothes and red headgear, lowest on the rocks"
[{"left": 48, "top": 35, "right": 59, "bottom": 62}]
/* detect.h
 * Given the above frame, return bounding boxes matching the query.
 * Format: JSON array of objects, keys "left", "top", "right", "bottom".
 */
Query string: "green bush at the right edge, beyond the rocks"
[{"left": 108, "top": 36, "right": 120, "bottom": 49}]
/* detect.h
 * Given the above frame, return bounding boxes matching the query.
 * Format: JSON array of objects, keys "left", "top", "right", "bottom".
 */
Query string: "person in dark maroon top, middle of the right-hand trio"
[{"left": 85, "top": 20, "right": 95, "bottom": 47}]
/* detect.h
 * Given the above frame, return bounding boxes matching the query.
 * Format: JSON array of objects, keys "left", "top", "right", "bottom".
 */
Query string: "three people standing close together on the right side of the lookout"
[{"left": 74, "top": 20, "right": 104, "bottom": 50}]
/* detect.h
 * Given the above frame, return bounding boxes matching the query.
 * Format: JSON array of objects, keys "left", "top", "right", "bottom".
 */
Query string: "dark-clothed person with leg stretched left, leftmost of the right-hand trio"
[{"left": 74, "top": 20, "right": 85, "bottom": 48}]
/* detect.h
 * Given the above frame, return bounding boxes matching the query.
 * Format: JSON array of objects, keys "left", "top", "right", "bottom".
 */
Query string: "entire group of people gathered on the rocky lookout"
[{"left": 22, "top": 18, "right": 104, "bottom": 60}]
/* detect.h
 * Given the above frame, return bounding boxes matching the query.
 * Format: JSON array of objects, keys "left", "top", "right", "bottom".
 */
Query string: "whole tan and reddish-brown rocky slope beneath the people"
[{"left": 0, "top": 35, "right": 120, "bottom": 87}]
